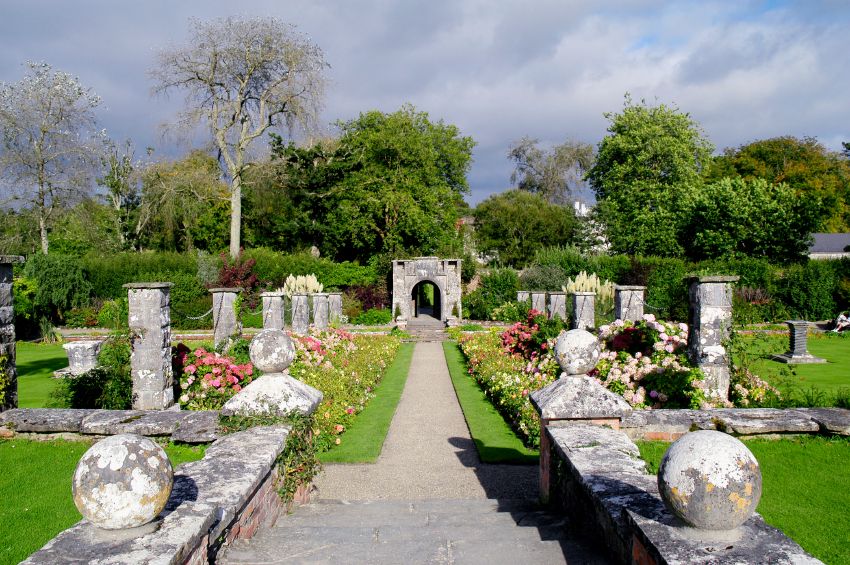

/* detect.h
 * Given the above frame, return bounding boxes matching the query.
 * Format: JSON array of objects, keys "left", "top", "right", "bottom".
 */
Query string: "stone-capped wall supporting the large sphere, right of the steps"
[{"left": 545, "top": 424, "right": 820, "bottom": 565}]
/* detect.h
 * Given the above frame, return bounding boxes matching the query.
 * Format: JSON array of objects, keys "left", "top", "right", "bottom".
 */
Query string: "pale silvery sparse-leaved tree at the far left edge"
[{"left": 0, "top": 63, "right": 103, "bottom": 254}]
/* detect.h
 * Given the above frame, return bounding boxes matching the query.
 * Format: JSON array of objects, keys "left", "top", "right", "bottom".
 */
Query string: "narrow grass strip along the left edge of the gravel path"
[{"left": 319, "top": 343, "right": 414, "bottom": 463}]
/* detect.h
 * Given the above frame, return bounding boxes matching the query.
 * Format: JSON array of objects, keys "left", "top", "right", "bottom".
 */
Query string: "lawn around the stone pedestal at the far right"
[{"left": 744, "top": 334, "right": 850, "bottom": 397}]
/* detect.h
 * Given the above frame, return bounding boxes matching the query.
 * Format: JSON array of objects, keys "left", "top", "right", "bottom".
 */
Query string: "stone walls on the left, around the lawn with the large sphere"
[{"left": 0, "top": 408, "right": 303, "bottom": 565}]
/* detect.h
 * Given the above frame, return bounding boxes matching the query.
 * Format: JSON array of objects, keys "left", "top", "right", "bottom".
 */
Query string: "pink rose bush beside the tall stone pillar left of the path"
[{"left": 172, "top": 343, "right": 254, "bottom": 410}]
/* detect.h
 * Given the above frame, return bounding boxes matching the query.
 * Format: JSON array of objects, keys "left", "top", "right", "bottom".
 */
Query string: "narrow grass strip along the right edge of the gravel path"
[{"left": 443, "top": 341, "right": 540, "bottom": 465}]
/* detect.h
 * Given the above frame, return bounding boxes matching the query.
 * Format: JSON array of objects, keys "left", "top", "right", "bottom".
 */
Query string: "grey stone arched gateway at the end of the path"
[{"left": 393, "top": 257, "right": 461, "bottom": 325}]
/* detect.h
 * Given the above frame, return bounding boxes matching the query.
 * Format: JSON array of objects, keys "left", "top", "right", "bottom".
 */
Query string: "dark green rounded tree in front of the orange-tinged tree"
[{"left": 682, "top": 177, "right": 822, "bottom": 262}]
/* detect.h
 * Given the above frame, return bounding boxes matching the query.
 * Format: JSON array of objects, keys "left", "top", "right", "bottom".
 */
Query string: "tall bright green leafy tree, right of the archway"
[{"left": 587, "top": 96, "right": 714, "bottom": 257}]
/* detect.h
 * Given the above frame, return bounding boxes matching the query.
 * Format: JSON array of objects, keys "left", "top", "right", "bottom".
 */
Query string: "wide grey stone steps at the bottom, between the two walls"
[{"left": 218, "top": 500, "right": 601, "bottom": 564}]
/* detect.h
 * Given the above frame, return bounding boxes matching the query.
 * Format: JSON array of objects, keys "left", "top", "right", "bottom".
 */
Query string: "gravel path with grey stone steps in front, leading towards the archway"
[{"left": 218, "top": 342, "right": 604, "bottom": 565}]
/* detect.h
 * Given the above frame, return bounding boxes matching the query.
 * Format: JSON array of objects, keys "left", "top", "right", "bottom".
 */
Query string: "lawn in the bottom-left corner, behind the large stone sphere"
[{"left": 0, "top": 436, "right": 204, "bottom": 564}]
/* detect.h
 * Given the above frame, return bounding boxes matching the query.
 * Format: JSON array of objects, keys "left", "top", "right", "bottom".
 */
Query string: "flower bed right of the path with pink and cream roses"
[{"left": 458, "top": 311, "right": 778, "bottom": 446}]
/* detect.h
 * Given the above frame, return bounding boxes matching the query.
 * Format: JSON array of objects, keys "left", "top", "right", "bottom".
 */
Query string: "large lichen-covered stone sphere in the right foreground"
[{"left": 658, "top": 430, "right": 761, "bottom": 530}]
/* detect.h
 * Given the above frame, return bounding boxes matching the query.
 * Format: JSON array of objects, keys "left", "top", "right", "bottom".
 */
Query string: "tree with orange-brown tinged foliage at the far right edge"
[{"left": 706, "top": 136, "right": 850, "bottom": 232}]
